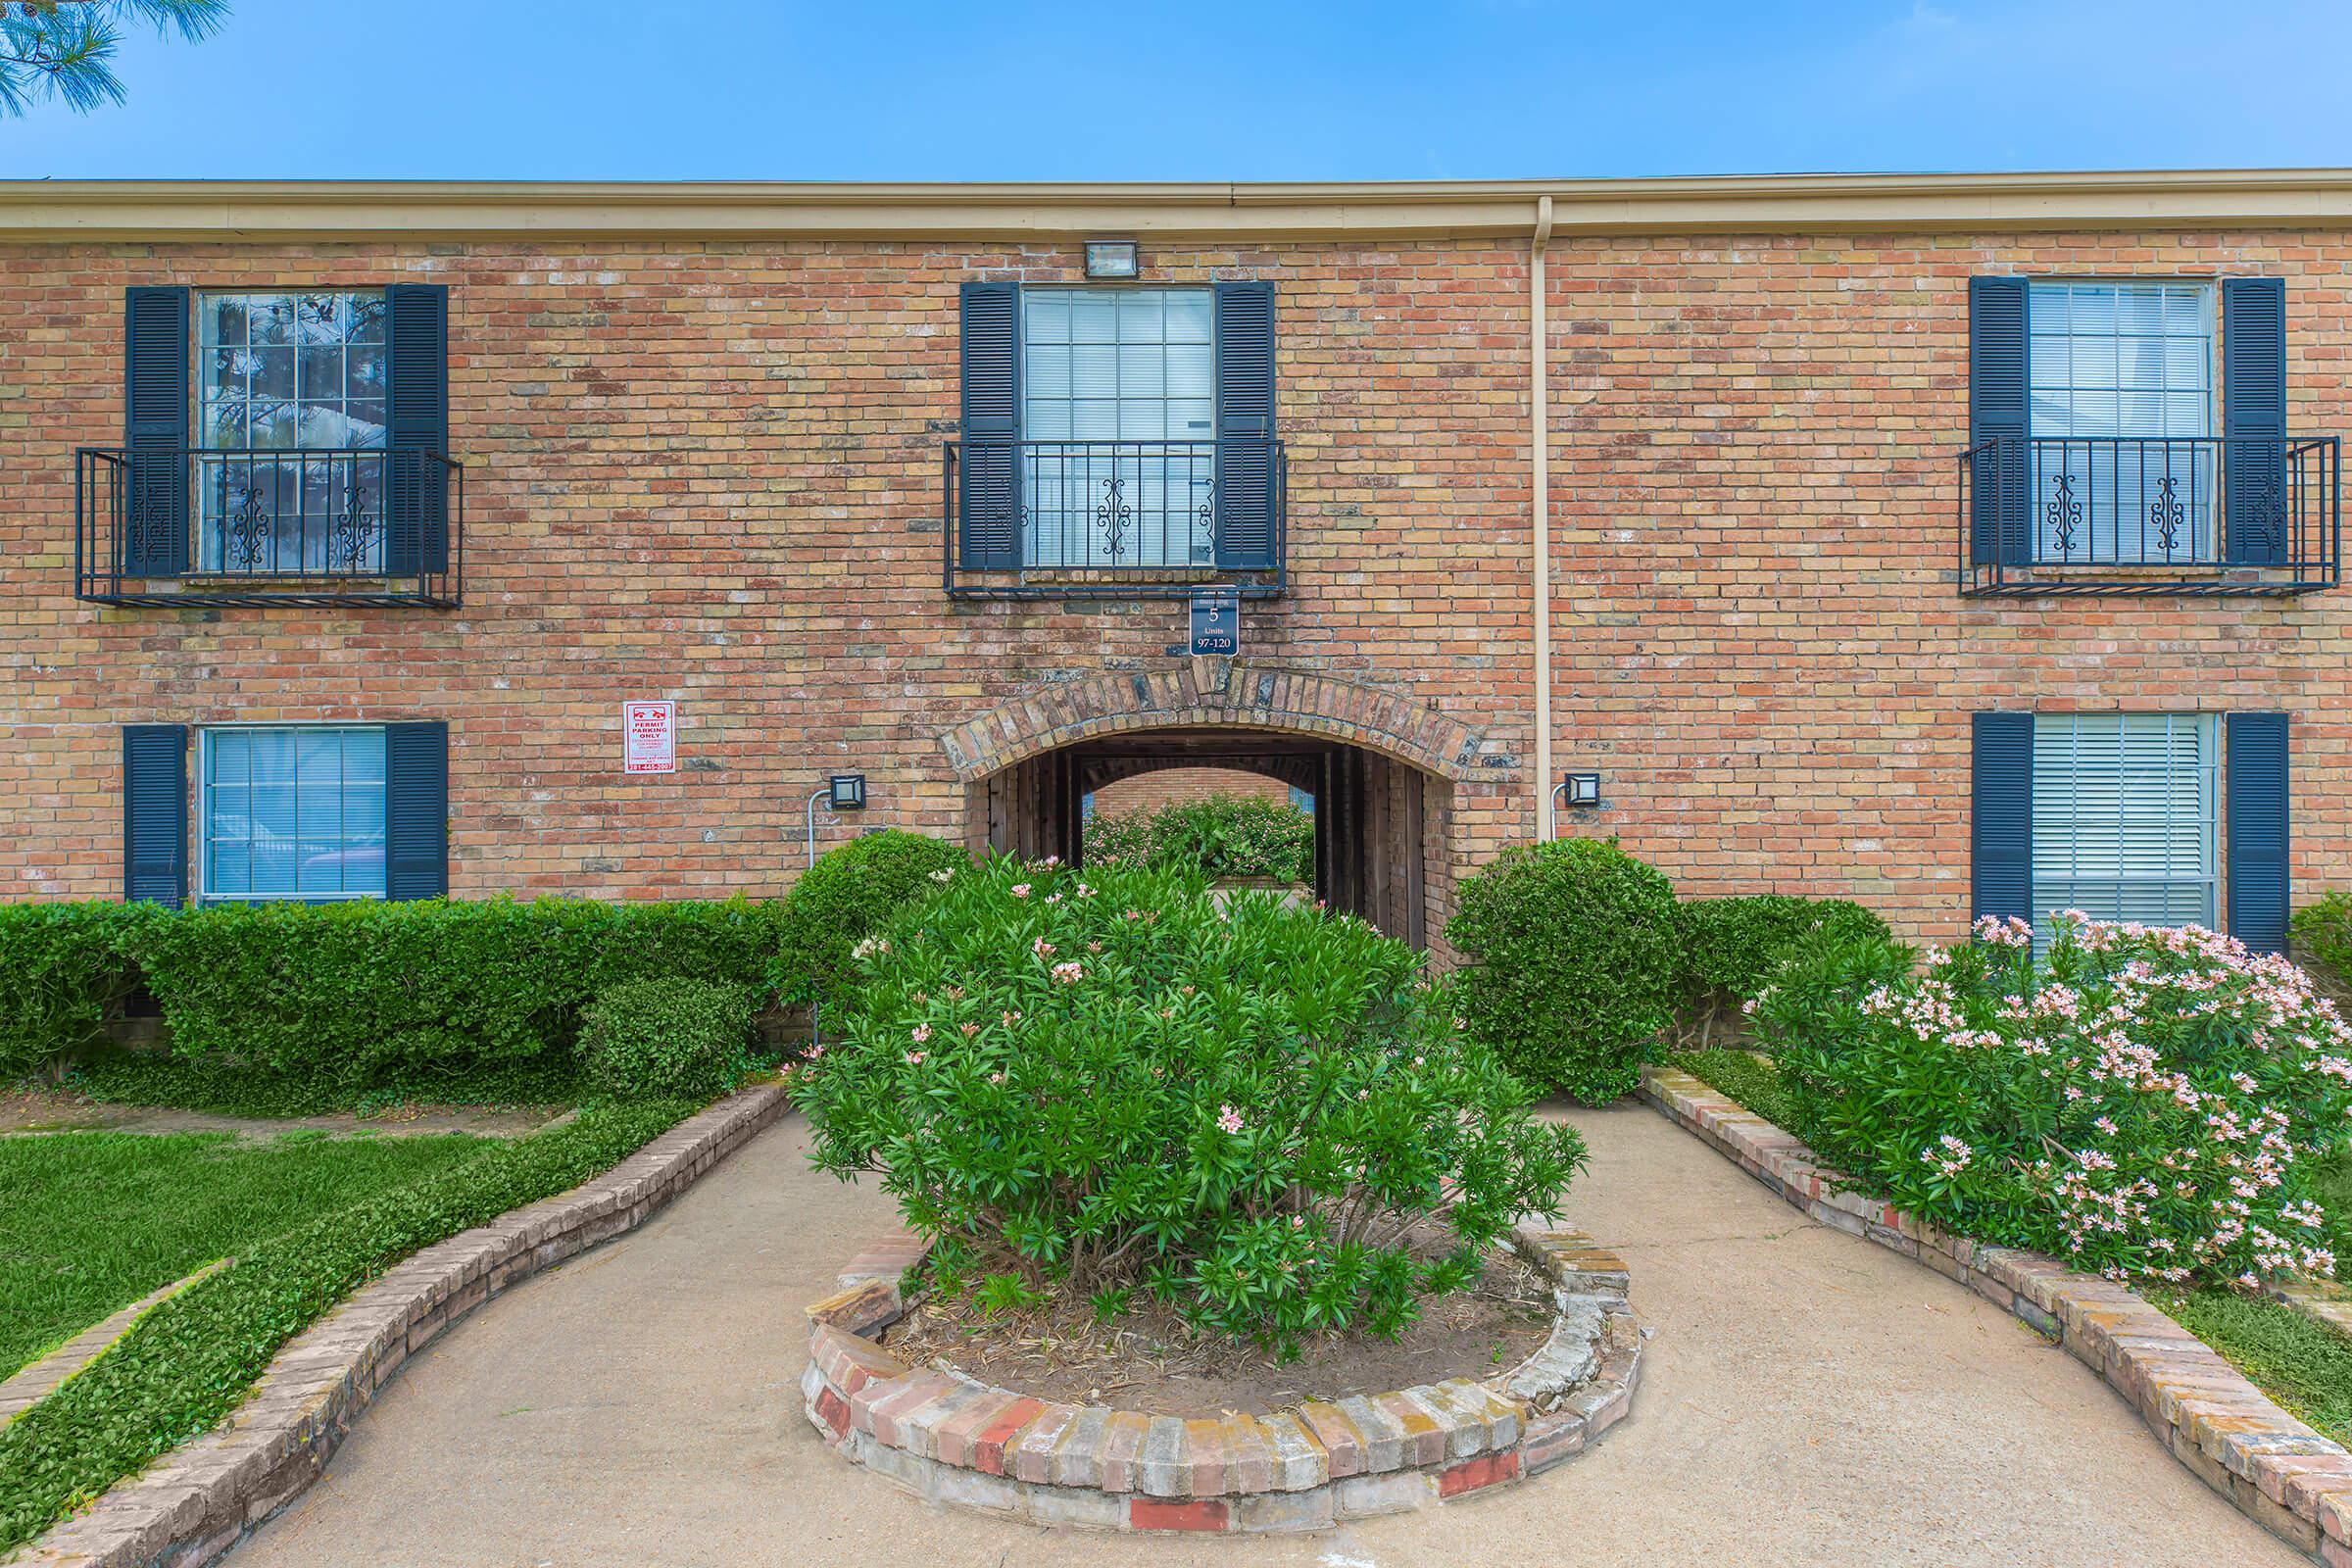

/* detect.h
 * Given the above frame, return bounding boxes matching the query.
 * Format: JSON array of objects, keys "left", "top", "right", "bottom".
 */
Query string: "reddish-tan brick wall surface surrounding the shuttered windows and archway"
[{"left": 0, "top": 232, "right": 2352, "bottom": 936}]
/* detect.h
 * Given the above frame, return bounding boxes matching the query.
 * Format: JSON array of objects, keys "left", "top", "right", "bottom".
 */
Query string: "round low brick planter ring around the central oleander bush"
[{"left": 800, "top": 1220, "right": 1644, "bottom": 1533}]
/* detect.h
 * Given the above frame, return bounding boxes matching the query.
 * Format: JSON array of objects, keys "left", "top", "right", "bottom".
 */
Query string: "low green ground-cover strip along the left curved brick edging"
[{"left": 0, "top": 1101, "right": 692, "bottom": 1554}]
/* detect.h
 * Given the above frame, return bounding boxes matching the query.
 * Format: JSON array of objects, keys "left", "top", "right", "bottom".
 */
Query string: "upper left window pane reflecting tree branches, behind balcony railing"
[{"left": 193, "top": 289, "right": 386, "bottom": 573}]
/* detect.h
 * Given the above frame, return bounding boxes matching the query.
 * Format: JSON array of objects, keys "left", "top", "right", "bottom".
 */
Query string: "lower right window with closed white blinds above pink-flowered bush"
[{"left": 2033, "top": 712, "right": 2218, "bottom": 931}]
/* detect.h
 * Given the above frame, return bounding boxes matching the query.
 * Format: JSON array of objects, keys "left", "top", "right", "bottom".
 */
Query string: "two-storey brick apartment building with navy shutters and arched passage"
[{"left": 0, "top": 172, "right": 2352, "bottom": 958}]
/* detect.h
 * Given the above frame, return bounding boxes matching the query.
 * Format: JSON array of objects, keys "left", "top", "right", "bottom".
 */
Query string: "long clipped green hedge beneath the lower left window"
[{"left": 0, "top": 832, "right": 969, "bottom": 1098}]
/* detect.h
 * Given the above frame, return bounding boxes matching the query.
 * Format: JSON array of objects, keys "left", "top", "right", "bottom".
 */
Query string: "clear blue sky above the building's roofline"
[{"left": 0, "top": 0, "right": 2352, "bottom": 181}]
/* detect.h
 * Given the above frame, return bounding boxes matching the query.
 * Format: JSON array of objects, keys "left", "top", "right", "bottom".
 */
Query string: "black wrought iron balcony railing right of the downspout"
[{"left": 1959, "top": 435, "right": 2342, "bottom": 597}]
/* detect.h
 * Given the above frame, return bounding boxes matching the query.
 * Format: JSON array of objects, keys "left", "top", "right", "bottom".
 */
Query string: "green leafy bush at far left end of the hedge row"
[{"left": 0, "top": 903, "right": 163, "bottom": 1084}]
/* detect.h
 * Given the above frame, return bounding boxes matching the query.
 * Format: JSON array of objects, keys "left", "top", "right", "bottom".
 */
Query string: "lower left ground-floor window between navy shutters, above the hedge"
[{"left": 200, "top": 724, "right": 383, "bottom": 901}]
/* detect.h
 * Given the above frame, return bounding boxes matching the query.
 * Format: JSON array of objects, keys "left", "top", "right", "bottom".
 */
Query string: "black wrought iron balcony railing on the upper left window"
[{"left": 73, "top": 447, "right": 466, "bottom": 607}]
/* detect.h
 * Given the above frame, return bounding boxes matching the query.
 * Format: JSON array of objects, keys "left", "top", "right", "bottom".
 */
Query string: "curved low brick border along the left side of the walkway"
[{"left": 10, "top": 1084, "right": 788, "bottom": 1568}]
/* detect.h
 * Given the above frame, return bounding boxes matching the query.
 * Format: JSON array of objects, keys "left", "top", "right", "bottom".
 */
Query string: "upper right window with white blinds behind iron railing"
[{"left": 2028, "top": 282, "right": 2216, "bottom": 562}]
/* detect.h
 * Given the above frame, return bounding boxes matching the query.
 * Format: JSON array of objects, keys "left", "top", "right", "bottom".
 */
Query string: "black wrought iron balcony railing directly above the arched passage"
[{"left": 939, "top": 437, "right": 1289, "bottom": 600}]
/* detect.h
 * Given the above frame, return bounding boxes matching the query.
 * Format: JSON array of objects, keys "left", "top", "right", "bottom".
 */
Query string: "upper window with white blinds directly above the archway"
[{"left": 1021, "top": 289, "right": 1216, "bottom": 566}]
